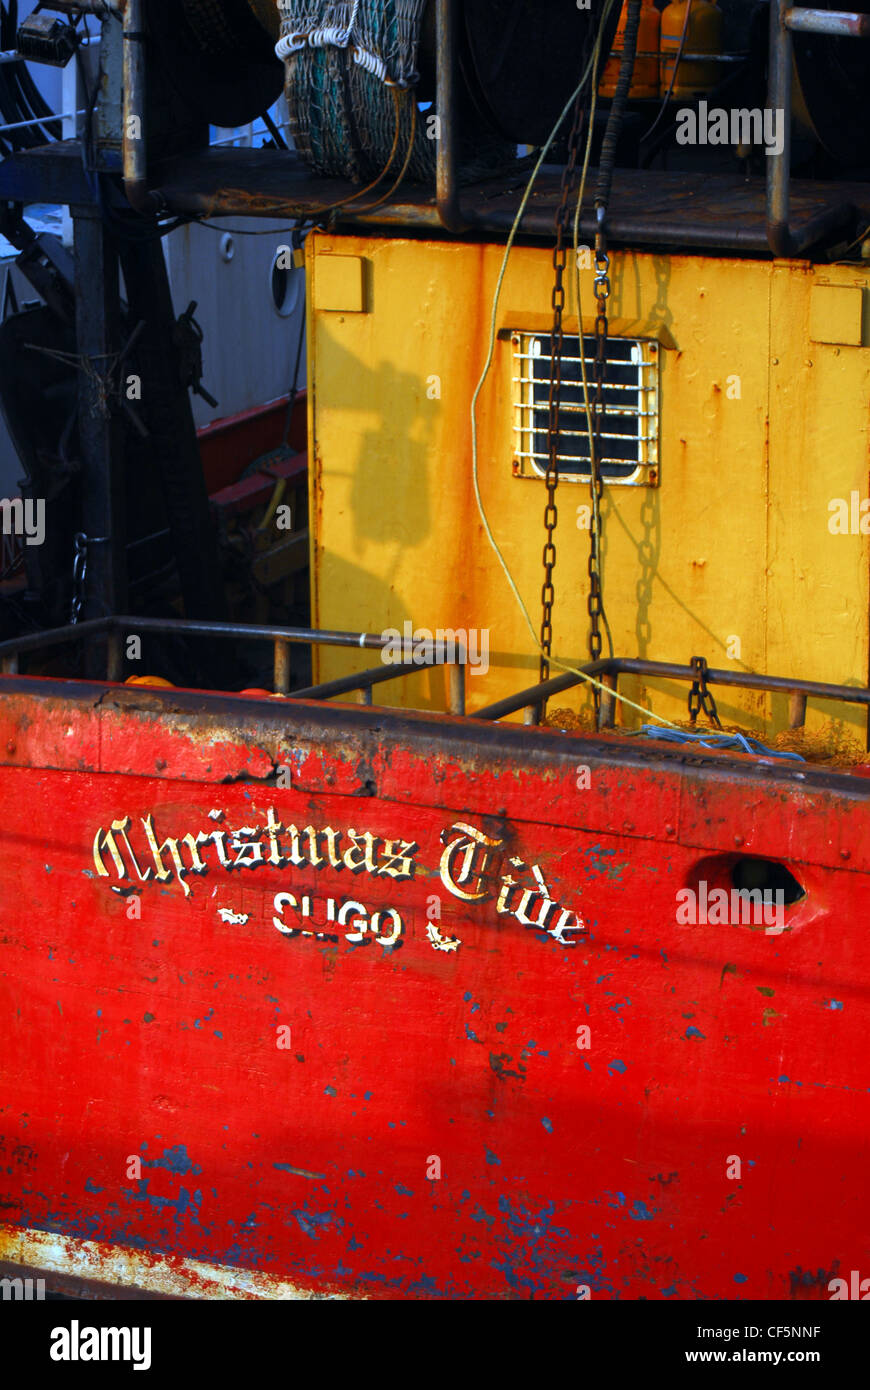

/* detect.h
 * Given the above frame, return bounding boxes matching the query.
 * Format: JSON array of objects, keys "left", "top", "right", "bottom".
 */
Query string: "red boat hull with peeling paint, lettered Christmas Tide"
[{"left": 0, "top": 677, "right": 870, "bottom": 1300}]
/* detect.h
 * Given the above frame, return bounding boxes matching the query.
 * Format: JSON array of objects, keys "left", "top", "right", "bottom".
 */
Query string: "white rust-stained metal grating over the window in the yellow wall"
[{"left": 511, "top": 332, "right": 659, "bottom": 485}]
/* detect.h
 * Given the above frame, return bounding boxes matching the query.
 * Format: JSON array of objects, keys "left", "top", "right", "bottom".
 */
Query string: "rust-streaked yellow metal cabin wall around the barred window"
[{"left": 309, "top": 234, "right": 870, "bottom": 737}]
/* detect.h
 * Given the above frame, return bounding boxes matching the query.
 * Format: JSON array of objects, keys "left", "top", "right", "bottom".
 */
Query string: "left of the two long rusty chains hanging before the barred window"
[{"left": 541, "top": 92, "right": 584, "bottom": 681}]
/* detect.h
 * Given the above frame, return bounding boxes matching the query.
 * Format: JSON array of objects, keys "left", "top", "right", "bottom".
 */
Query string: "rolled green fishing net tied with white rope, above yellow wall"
[{"left": 275, "top": 0, "right": 513, "bottom": 183}]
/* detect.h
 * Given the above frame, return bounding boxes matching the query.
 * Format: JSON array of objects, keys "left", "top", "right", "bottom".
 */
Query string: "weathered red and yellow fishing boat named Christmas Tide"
[{"left": 0, "top": 0, "right": 870, "bottom": 1301}]
